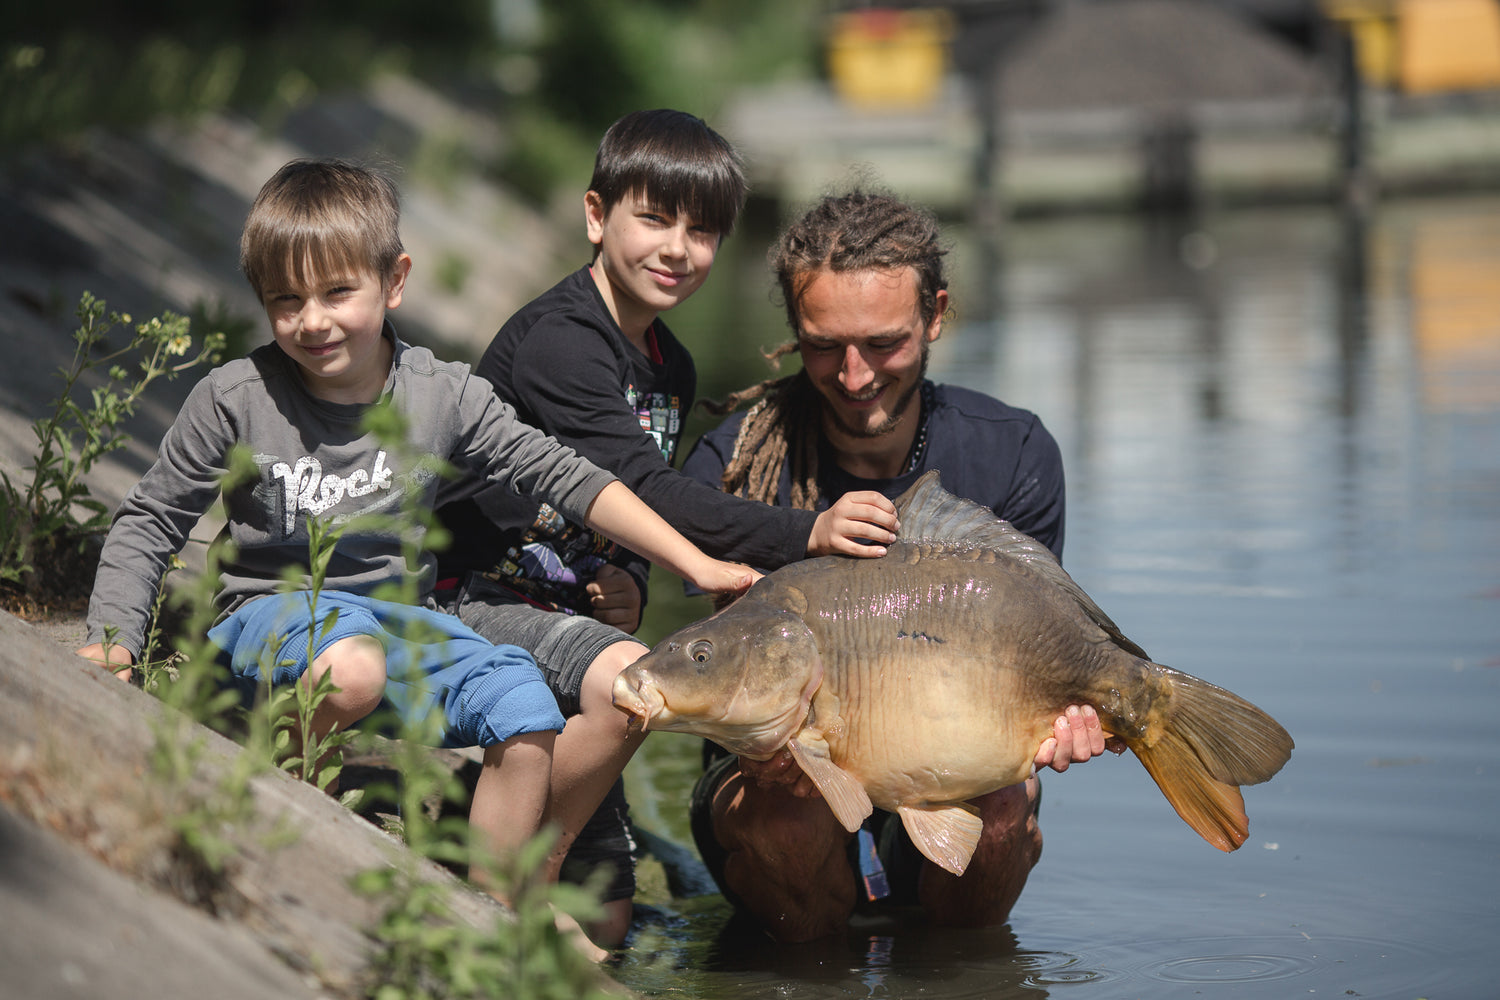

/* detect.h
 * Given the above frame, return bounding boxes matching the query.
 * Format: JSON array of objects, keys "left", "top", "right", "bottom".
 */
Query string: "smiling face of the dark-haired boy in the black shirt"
[{"left": 584, "top": 190, "right": 720, "bottom": 346}]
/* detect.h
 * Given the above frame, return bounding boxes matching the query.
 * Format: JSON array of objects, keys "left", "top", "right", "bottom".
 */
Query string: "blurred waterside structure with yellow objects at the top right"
[{"left": 729, "top": 0, "right": 1500, "bottom": 213}]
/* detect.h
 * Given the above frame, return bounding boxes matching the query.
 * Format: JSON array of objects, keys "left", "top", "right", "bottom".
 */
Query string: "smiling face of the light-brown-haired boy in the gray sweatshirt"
[{"left": 261, "top": 253, "right": 411, "bottom": 403}]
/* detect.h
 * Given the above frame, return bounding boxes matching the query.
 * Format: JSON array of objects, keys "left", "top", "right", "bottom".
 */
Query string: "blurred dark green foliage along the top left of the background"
[{"left": 0, "top": 0, "right": 822, "bottom": 201}]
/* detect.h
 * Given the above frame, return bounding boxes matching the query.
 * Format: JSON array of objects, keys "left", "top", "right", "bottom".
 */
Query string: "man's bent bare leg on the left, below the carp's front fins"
[{"left": 711, "top": 768, "right": 857, "bottom": 943}]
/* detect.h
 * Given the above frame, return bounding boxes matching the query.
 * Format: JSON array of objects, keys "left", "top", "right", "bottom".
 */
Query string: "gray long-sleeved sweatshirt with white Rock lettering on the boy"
[{"left": 86, "top": 322, "right": 615, "bottom": 657}]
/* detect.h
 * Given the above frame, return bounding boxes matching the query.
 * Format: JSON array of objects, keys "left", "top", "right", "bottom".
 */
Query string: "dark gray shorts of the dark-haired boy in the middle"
[{"left": 434, "top": 573, "right": 636, "bottom": 903}]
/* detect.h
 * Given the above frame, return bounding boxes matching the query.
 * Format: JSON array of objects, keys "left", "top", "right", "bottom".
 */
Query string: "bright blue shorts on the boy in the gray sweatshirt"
[{"left": 209, "top": 591, "right": 564, "bottom": 747}]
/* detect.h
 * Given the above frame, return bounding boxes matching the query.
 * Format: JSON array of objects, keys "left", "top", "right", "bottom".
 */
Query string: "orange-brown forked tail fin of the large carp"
[{"left": 1128, "top": 667, "right": 1293, "bottom": 852}]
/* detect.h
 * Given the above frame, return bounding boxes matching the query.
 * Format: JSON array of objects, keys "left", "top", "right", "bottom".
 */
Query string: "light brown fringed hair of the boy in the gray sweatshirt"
[{"left": 240, "top": 159, "right": 402, "bottom": 295}]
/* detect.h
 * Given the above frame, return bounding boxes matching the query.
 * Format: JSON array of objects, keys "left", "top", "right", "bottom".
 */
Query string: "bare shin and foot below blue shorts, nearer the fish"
[{"left": 470, "top": 732, "right": 609, "bottom": 961}]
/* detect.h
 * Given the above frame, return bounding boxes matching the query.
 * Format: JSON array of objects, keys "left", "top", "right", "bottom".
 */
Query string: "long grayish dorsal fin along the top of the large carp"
[{"left": 896, "top": 469, "right": 1151, "bottom": 660}]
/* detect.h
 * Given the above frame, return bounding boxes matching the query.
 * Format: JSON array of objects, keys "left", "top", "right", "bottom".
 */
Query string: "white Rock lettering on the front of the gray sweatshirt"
[{"left": 252, "top": 450, "right": 434, "bottom": 541}]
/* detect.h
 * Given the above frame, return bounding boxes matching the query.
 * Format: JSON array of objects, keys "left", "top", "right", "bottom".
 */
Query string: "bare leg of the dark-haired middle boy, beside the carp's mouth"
[{"left": 548, "top": 640, "right": 647, "bottom": 948}]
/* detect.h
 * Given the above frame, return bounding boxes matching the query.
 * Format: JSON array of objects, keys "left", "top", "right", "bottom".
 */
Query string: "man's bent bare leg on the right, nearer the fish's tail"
[{"left": 917, "top": 775, "right": 1041, "bottom": 927}]
